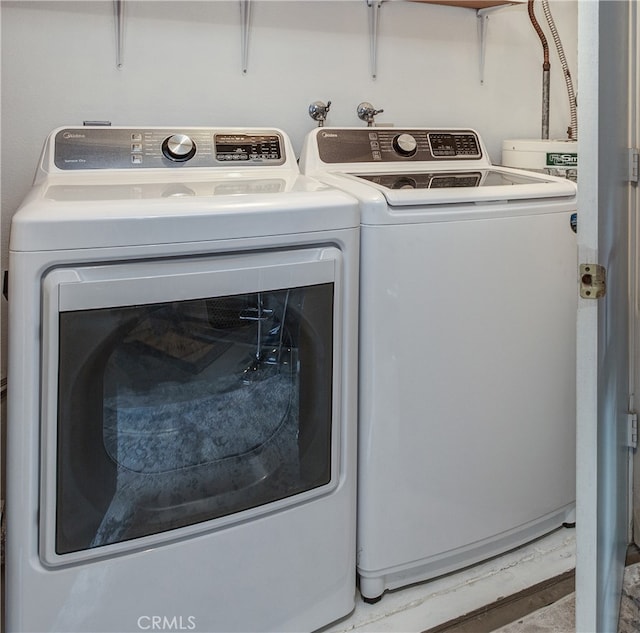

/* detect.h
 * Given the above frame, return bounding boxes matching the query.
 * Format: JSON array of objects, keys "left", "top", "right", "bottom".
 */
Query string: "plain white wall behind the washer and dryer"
[{"left": 1, "top": 0, "right": 577, "bottom": 376}]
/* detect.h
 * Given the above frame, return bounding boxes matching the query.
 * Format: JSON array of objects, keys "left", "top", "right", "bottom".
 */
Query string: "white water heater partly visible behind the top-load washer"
[{"left": 502, "top": 139, "right": 578, "bottom": 181}]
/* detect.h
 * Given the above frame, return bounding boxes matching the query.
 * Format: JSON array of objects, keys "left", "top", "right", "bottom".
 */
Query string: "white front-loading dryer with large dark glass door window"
[{"left": 5, "top": 127, "right": 359, "bottom": 633}]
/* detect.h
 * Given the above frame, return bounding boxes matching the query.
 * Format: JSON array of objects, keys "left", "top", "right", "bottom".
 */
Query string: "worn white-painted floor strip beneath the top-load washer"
[{"left": 322, "top": 528, "right": 575, "bottom": 633}]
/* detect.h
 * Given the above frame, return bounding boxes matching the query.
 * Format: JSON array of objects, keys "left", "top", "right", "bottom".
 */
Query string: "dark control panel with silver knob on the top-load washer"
[{"left": 317, "top": 128, "right": 482, "bottom": 163}]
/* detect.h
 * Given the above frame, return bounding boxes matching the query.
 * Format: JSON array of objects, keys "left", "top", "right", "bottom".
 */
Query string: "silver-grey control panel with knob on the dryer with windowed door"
[{"left": 53, "top": 127, "right": 286, "bottom": 170}]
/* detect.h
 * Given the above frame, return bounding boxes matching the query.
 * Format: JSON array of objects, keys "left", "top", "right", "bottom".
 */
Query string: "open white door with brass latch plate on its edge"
[{"left": 576, "top": 0, "right": 637, "bottom": 633}]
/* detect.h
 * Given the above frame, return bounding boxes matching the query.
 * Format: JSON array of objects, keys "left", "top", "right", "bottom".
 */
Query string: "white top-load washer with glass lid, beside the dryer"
[{"left": 300, "top": 127, "right": 577, "bottom": 601}]
